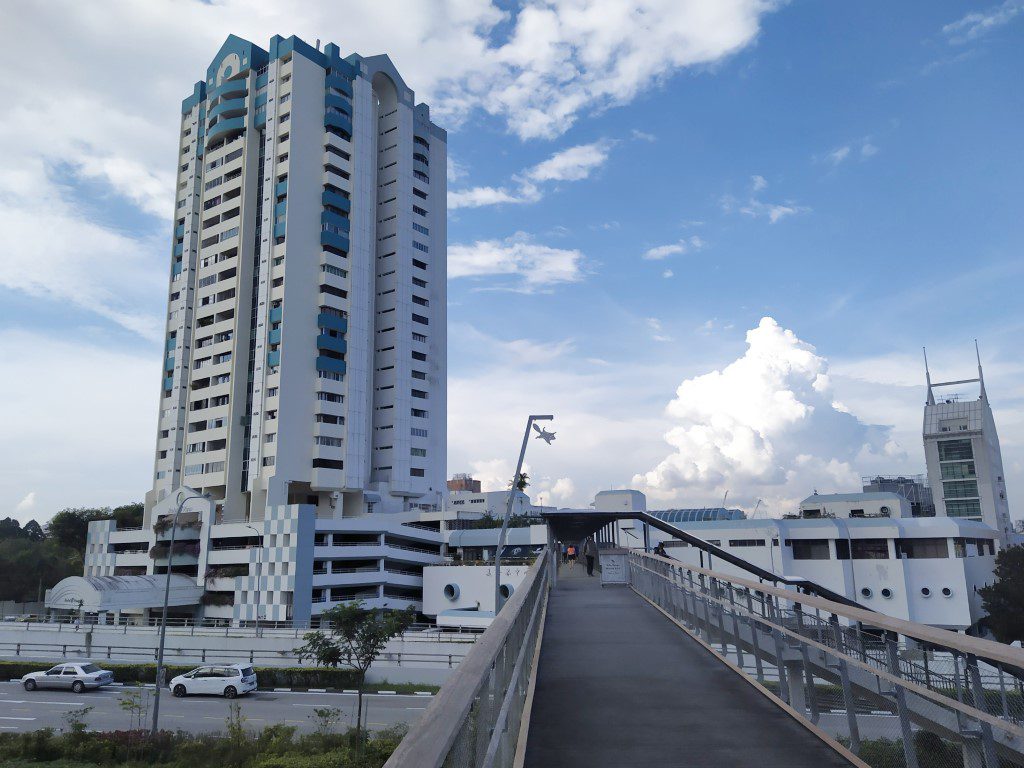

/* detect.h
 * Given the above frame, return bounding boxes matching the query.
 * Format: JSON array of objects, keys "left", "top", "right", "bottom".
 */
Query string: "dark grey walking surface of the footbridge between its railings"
[{"left": 526, "top": 564, "right": 849, "bottom": 768}]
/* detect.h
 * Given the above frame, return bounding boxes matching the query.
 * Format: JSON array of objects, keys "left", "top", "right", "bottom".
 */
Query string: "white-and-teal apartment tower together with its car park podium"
[{"left": 55, "top": 36, "right": 446, "bottom": 622}]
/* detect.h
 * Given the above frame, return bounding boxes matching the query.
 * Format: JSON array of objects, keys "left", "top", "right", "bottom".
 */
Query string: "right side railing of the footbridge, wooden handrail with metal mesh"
[{"left": 630, "top": 553, "right": 1024, "bottom": 768}]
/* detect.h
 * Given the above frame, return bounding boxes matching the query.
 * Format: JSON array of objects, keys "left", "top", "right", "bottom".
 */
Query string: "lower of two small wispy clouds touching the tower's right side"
[{"left": 449, "top": 232, "right": 584, "bottom": 293}]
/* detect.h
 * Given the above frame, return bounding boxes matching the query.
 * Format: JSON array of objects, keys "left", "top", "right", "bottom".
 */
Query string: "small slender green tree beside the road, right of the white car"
[{"left": 294, "top": 600, "right": 416, "bottom": 736}]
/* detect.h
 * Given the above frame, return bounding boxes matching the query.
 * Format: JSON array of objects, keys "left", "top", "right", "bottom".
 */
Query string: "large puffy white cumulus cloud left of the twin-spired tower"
[{"left": 633, "top": 317, "right": 891, "bottom": 513}]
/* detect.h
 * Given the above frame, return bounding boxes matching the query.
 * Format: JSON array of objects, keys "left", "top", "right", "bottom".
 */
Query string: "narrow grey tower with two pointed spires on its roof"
[{"left": 924, "top": 348, "right": 1012, "bottom": 544}]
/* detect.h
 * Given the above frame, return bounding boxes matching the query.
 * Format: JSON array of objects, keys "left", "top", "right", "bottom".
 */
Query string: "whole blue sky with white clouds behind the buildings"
[{"left": 0, "top": 0, "right": 1024, "bottom": 519}]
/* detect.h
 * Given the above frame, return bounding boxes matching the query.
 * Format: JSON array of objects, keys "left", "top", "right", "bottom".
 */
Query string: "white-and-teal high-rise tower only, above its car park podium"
[{"left": 147, "top": 36, "right": 446, "bottom": 522}]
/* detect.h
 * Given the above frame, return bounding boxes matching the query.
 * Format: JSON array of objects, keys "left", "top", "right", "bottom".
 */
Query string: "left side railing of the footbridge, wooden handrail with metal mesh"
[{"left": 385, "top": 551, "right": 550, "bottom": 768}]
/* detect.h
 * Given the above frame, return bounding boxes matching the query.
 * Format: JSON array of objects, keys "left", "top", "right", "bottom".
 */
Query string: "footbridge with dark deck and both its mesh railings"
[{"left": 386, "top": 528, "right": 1024, "bottom": 768}]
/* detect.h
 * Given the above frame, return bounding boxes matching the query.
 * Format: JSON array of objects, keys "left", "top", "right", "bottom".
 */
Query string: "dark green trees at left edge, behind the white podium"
[{"left": 0, "top": 502, "right": 142, "bottom": 602}]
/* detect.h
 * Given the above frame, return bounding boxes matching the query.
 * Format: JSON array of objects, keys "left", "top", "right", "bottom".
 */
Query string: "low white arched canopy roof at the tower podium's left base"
[{"left": 46, "top": 573, "right": 204, "bottom": 613}]
